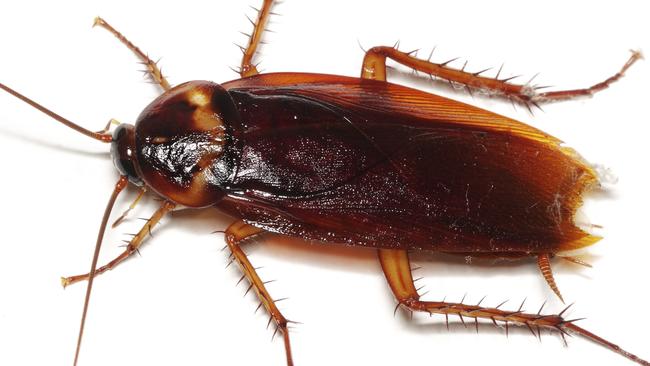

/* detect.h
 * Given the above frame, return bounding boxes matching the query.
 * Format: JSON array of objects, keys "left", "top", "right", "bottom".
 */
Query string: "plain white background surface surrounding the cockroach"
[{"left": 0, "top": 0, "right": 650, "bottom": 365}]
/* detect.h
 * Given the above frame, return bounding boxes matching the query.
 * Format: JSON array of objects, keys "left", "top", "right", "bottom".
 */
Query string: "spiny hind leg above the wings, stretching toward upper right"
[{"left": 361, "top": 46, "right": 643, "bottom": 106}]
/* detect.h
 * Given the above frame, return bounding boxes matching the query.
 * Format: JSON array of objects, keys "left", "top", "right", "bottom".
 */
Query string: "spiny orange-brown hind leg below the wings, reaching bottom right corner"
[{"left": 378, "top": 249, "right": 650, "bottom": 366}]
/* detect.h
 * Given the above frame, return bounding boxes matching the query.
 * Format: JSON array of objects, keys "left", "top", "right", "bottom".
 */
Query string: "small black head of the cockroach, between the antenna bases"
[{"left": 111, "top": 123, "right": 142, "bottom": 186}]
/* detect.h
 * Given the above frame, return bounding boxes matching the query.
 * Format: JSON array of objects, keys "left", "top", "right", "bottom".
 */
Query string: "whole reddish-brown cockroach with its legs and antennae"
[{"left": 0, "top": 0, "right": 649, "bottom": 366}]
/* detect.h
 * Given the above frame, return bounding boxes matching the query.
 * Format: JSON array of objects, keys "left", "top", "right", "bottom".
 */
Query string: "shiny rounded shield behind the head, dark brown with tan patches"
[{"left": 129, "top": 81, "right": 240, "bottom": 207}]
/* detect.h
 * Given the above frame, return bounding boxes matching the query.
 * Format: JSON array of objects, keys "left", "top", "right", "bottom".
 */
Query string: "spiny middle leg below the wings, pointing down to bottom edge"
[{"left": 226, "top": 220, "right": 293, "bottom": 366}]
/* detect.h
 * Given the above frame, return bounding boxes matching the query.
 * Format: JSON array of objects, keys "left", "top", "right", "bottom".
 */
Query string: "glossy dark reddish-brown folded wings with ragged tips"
[{"left": 222, "top": 74, "right": 599, "bottom": 256}]
